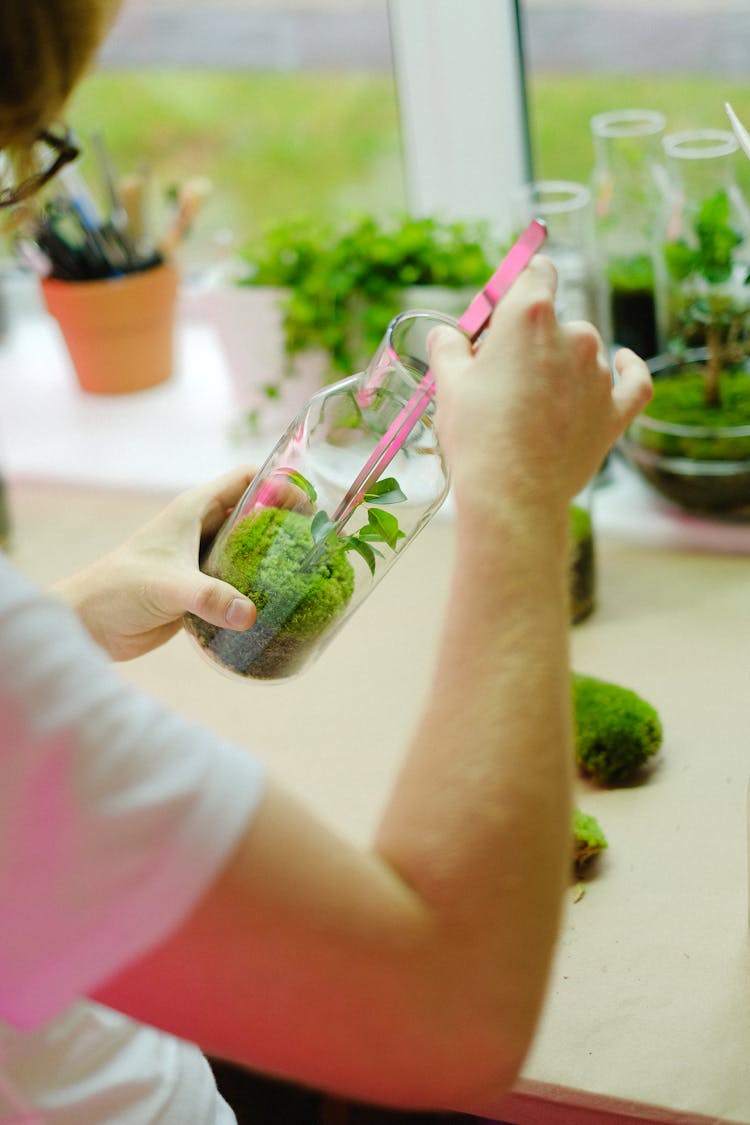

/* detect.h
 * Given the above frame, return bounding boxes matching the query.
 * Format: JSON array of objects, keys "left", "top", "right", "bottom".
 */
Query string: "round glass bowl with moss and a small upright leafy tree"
[{"left": 622, "top": 189, "right": 750, "bottom": 514}]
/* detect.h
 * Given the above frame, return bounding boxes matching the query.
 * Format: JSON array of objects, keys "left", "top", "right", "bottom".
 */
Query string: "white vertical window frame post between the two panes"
[{"left": 388, "top": 0, "right": 531, "bottom": 235}]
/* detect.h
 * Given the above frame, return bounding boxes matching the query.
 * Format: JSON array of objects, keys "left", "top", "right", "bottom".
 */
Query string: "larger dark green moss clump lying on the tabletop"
[{"left": 572, "top": 673, "right": 663, "bottom": 785}]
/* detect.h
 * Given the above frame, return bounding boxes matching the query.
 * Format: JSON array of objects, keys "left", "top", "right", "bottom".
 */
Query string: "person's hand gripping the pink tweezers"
[{"left": 430, "top": 257, "right": 651, "bottom": 507}]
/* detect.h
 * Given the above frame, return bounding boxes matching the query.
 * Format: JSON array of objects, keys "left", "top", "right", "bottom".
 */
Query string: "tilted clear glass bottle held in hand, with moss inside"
[{"left": 184, "top": 309, "right": 457, "bottom": 681}]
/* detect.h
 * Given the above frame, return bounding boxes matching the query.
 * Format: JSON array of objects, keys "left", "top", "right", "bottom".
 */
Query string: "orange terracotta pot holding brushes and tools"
[{"left": 42, "top": 264, "right": 178, "bottom": 395}]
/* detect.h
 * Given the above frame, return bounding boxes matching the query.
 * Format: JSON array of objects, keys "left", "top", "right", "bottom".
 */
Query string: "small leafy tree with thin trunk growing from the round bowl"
[{"left": 663, "top": 189, "right": 750, "bottom": 408}]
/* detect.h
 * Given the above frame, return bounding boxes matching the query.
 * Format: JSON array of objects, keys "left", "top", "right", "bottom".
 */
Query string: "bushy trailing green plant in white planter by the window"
[{"left": 241, "top": 215, "right": 500, "bottom": 380}]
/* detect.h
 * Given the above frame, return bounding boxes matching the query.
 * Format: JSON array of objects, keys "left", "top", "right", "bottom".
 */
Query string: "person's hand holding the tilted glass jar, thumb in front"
[{"left": 54, "top": 469, "right": 255, "bottom": 660}]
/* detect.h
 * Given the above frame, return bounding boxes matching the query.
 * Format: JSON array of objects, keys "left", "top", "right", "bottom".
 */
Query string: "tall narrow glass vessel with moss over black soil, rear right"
[{"left": 590, "top": 109, "right": 667, "bottom": 359}]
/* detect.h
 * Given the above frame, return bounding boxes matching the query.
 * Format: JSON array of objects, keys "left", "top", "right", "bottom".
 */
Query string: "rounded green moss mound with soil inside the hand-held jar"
[{"left": 188, "top": 507, "right": 354, "bottom": 680}]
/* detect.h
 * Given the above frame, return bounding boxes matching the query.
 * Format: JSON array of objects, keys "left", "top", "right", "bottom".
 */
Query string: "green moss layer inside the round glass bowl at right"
[{"left": 636, "top": 367, "right": 750, "bottom": 461}]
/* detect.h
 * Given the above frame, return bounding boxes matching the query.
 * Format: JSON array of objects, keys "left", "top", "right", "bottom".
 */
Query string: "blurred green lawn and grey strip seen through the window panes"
[{"left": 45, "top": 0, "right": 750, "bottom": 267}]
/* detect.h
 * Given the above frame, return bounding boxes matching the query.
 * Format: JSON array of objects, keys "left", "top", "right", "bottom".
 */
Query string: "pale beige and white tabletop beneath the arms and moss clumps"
[{"left": 0, "top": 285, "right": 750, "bottom": 1125}]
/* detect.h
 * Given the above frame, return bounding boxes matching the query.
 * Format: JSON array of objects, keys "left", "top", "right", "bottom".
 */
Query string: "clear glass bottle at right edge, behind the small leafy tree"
[{"left": 656, "top": 129, "right": 750, "bottom": 368}]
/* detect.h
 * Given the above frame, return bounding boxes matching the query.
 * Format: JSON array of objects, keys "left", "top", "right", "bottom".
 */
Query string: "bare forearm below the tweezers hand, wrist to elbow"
[{"left": 377, "top": 512, "right": 571, "bottom": 1071}]
